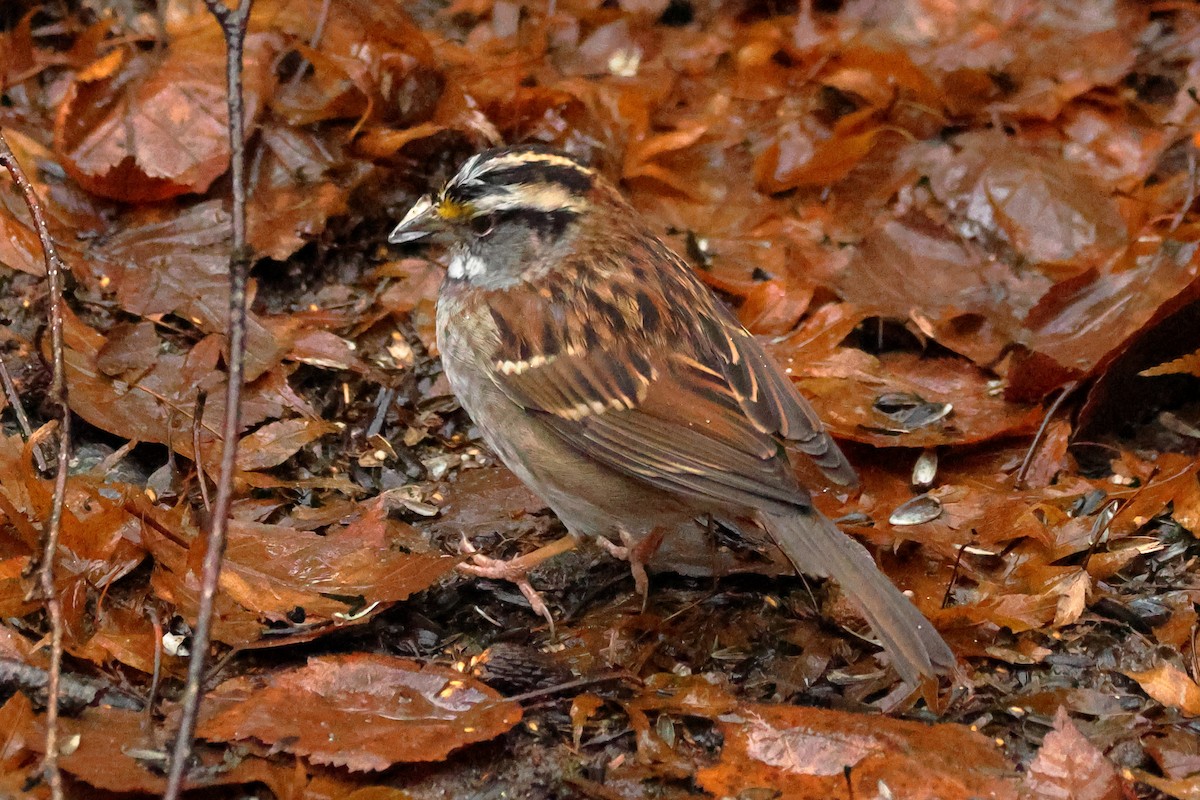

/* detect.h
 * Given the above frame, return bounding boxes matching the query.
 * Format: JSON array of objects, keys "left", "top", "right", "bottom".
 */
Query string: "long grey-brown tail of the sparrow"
[{"left": 762, "top": 509, "right": 955, "bottom": 684}]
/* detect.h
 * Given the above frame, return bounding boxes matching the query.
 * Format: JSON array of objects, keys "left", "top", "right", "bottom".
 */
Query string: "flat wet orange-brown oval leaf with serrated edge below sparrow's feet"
[{"left": 197, "top": 654, "right": 521, "bottom": 771}]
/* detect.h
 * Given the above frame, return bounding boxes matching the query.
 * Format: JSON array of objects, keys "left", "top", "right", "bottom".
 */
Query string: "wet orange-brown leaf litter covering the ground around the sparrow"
[{"left": 0, "top": 0, "right": 1200, "bottom": 799}]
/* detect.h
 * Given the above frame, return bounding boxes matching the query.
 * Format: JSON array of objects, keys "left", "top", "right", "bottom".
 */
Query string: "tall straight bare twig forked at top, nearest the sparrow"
[{"left": 163, "top": 0, "right": 253, "bottom": 800}]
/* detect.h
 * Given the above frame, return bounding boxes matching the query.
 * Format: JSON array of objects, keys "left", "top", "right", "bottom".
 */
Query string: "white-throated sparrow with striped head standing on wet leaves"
[{"left": 389, "top": 146, "right": 954, "bottom": 682}]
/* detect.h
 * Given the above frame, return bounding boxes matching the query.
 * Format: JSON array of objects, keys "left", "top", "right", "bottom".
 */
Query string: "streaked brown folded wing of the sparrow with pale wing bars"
[{"left": 477, "top": 240, "right": 854, "bottom": 511}]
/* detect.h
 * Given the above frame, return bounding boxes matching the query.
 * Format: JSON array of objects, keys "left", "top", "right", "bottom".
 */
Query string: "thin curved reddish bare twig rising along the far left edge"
[{"left": 0, "top": 133, "right": 71, "bottom": 800}]
